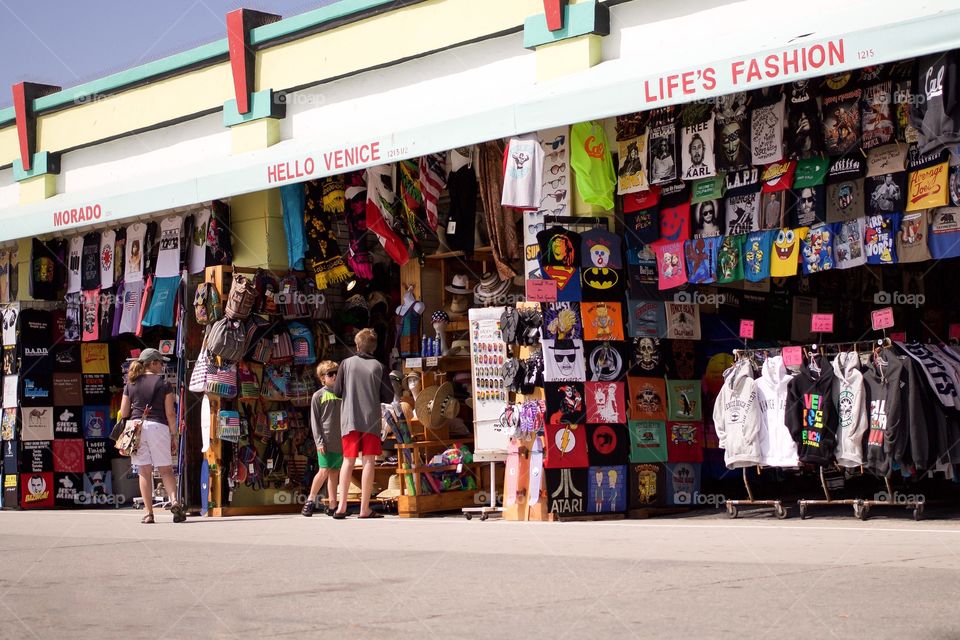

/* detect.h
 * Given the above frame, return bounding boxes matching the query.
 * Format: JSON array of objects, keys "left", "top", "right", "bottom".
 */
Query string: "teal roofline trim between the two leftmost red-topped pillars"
[{"left": 30, "top": 38, "right": 228, "bottom": 114}]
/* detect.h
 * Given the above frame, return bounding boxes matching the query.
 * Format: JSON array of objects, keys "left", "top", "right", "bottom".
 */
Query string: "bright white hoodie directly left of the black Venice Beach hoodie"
[{"left": 757, "top": 356, "right": 799, "bottom": 467}]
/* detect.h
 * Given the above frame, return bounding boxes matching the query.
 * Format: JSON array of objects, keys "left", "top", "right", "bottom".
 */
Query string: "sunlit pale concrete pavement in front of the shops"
[{"left": 0, "top": 510, "right": 960, "bottom": 640}]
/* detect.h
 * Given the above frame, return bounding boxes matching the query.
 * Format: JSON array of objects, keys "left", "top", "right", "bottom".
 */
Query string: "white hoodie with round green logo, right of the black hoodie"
[{"left": 833, "top": 351, "right": 869, "bottom": 467}]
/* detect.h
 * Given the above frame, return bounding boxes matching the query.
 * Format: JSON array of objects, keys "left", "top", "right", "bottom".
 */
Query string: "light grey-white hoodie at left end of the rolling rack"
[{"left": 713, "top": 360, "right": 760, "bottom": 469}]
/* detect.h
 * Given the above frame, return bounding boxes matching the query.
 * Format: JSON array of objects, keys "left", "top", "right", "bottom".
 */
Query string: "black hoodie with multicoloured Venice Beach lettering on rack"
[{"left": 784, "top": 354, "right": 837, "bottom": 465}]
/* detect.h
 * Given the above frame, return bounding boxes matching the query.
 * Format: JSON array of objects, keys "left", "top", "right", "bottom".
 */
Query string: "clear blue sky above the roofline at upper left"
[{"left": 0, "top": 0, "right": 334, "bottom": 107}]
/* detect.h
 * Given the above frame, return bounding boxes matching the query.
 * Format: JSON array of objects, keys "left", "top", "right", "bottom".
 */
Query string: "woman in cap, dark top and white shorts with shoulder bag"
[{"left": 120, "top": 349, "right": 187, "bottom": 524}]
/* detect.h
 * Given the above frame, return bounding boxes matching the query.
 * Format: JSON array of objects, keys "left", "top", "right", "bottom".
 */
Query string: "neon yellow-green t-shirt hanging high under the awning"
[{"left": 570, "top": 121, "right": 617, "bottom": 210}]
